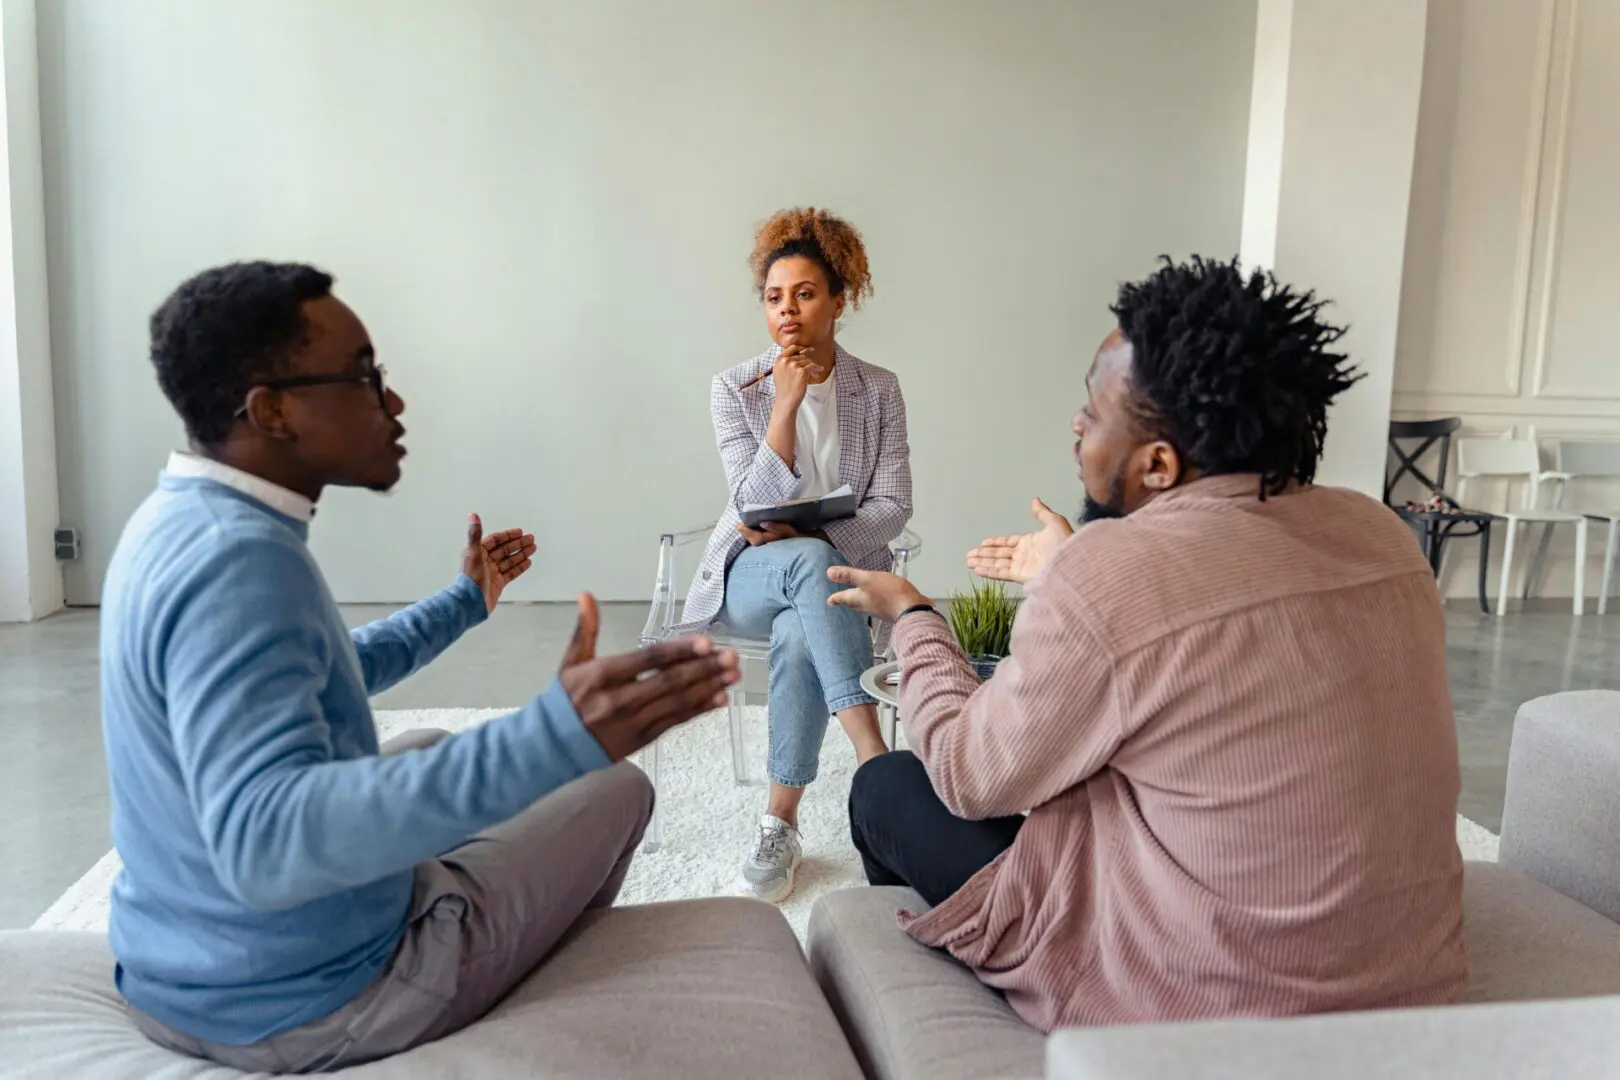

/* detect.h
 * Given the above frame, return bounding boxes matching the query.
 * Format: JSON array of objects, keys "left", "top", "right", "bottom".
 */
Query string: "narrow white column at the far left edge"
[{"left": 0, "top": 0, "right": 62, "bottom": 622}]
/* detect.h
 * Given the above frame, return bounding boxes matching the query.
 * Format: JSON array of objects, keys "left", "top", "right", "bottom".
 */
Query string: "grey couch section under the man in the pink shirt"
[{"left": 810, "top": 691, "right": 1620, "bottom": 1080}]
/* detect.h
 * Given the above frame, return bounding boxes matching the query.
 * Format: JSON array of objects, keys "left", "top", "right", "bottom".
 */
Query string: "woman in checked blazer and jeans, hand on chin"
[{"left": 685, "top": 209, "right": 912, "bottom": 902}]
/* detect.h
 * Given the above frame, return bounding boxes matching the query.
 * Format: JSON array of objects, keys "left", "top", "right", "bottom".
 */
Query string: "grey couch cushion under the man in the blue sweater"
[{"left": 0, "top": 899, "right": 860, "bottom": 1080}]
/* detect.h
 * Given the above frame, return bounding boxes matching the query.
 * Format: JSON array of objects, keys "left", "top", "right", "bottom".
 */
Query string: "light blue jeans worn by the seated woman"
[{"left": 719, "top": 538, "right": 872, "bottom": 787}]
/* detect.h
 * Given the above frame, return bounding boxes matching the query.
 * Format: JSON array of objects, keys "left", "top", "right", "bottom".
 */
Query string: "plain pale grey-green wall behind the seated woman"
[{"left": 41, "top": 0, "right": 1254, "bottom": 602}]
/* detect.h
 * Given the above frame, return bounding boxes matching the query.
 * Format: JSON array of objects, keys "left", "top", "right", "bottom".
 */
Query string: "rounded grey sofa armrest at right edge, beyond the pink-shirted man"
[{"left": 1499, "top": 690, "right": 1620, "bottom": 923}]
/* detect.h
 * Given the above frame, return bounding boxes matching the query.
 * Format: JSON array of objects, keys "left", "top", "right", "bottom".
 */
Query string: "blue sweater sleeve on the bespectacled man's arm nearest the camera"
[{"left": 162, "top": 538, "right": 609, "bottom": 908}]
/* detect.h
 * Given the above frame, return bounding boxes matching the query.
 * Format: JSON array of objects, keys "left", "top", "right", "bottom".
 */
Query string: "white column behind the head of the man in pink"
[{"left": 1241, "top": 0, "right": 1429, "bottom": 497}]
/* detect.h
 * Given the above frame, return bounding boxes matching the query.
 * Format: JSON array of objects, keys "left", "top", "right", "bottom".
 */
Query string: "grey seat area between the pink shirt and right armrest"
[{"left": 1463, "top": 863, "right": 1620, "bottom": 1001}]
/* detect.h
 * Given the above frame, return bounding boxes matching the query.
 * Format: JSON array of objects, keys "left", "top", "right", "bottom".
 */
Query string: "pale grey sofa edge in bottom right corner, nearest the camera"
[{"left": 1047, "top": 997, "right": 1620, "bottom": 1080}]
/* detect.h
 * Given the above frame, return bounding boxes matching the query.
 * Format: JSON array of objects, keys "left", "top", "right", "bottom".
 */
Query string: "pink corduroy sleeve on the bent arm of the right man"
[{"left": 894, "top": 544, "right": 1124, "bottom": 821}]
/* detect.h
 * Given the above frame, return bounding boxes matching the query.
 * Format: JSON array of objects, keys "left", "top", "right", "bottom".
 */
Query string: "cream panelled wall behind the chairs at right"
[{"left": 1395, "top": 0, "right": 1620, "bottom": 596}]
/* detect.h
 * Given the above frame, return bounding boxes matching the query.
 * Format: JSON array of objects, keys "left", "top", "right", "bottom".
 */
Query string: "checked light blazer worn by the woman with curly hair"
[{"left": 682, "top": 345, "right": 912, "bottom": 630}]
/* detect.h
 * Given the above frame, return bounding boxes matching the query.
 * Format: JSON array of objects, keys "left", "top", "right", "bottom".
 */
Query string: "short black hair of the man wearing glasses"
[{"left": 151, "top": 261, "right": 332, "bottom": 445}]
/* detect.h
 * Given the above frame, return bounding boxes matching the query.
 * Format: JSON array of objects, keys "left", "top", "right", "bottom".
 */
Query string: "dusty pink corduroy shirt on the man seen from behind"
[{"left": 894, "top": 476, "right": 1468, "bottom": 1031}]
